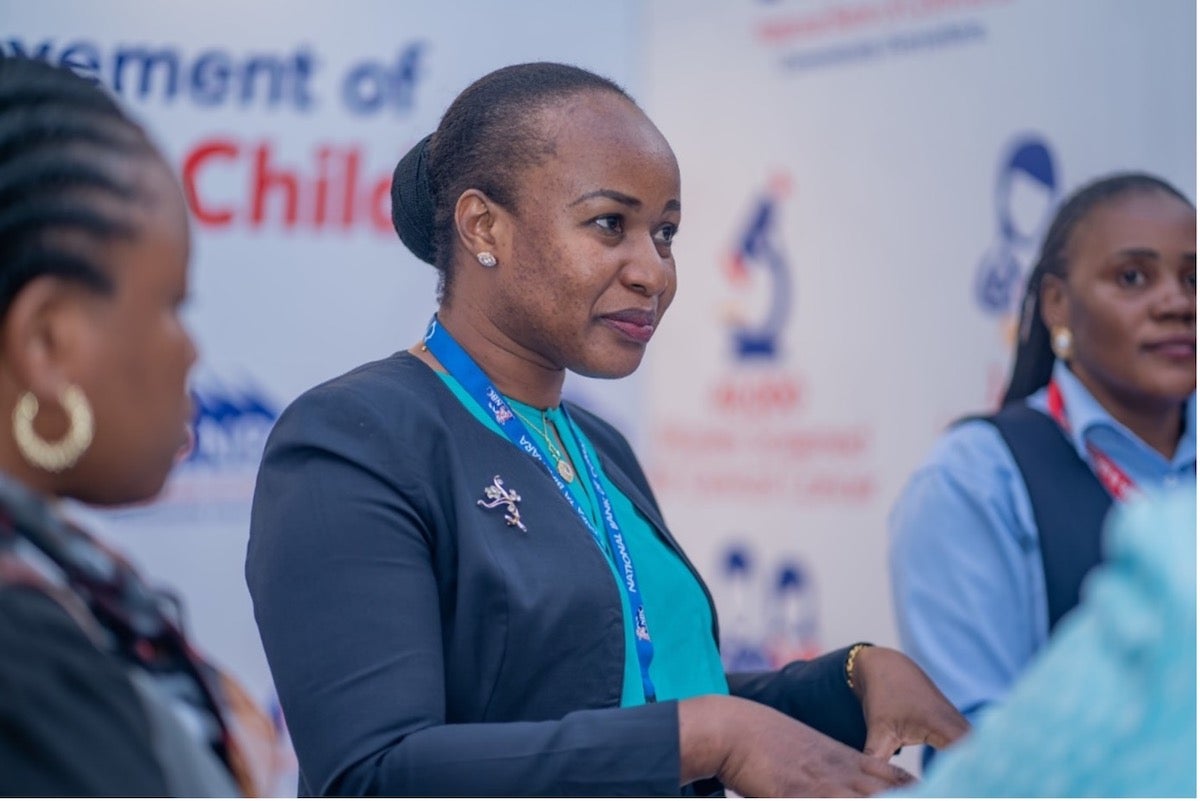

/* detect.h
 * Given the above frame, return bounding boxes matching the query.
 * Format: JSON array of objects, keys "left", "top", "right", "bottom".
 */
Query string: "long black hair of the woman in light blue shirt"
[{"left": 1003, "top": 173, "right": 1195, "bottom": 403}]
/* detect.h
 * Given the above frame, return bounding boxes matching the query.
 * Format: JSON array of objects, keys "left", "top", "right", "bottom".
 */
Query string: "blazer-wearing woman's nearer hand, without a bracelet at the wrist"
[{"left": 679, "top": 695, "right": 913, "bottom": 797}]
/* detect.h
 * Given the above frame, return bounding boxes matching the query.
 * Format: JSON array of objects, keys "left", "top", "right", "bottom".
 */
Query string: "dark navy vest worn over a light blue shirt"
[{"left": 980, "top": 401, "right": 1112, "bottom": 631}]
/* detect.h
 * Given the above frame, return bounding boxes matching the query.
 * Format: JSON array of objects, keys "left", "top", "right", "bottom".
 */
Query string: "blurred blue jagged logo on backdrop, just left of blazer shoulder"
[{"left": 184, "top": 380, "right": 280, "bottom": 468}]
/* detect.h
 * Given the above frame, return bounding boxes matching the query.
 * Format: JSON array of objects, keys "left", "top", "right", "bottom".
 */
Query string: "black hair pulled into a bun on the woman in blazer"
[{"left": 391, "top": 61, "right": 636, "bottom": 299}]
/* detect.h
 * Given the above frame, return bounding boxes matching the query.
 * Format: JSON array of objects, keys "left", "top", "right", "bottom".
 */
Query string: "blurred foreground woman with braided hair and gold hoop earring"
[{"left": 0, "top": 58, "right": 270, "bottom": 796}]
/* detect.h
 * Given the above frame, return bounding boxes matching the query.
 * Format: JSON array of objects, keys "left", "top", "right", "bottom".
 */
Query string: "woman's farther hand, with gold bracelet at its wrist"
[{"left": 851, "top": 645, "right": 971, "bottom": 759}]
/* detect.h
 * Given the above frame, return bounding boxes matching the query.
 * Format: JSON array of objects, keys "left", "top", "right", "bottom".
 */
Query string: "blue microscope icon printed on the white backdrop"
[{"left": 726, "top": 175, "right": 792, "bottom": 359}]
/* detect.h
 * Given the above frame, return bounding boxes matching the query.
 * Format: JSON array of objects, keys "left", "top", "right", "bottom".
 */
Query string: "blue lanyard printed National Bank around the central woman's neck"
[{"left": 425, "top": 314, "right": 655, "bottom": 704}]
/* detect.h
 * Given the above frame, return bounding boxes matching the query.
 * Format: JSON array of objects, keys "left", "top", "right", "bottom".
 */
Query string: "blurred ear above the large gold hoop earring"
[{"left": 0, "top": 276, "right": 88, "bottom": 398}]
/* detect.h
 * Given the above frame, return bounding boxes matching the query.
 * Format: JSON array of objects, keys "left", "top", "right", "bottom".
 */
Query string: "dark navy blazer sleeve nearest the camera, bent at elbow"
[{"left": 246, "top": 385, "right": 679, "bottom": 796}]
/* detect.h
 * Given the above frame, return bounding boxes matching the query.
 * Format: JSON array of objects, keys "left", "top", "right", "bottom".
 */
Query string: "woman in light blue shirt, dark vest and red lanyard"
[{"left": 889, "top": 174, "right": 1196, "bottom": 738}]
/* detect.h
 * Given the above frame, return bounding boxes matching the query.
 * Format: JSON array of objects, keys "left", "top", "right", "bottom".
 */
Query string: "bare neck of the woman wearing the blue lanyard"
[{"left": 413, "top": 306, "right": 566, "bottom": 409}]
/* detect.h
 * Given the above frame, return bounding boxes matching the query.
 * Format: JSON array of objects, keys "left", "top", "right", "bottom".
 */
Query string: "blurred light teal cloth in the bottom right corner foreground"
[{"left": 892, "top": 489, "right": 1196, "bottom": 797}]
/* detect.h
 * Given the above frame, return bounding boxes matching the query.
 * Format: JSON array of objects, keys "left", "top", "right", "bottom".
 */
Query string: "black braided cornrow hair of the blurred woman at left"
[{"left": 0, "top": 56, "right": 161, "bottom": 315}]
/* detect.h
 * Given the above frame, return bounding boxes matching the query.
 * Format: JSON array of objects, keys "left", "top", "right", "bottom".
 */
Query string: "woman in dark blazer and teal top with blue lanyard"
[{"left": 246, "top": 64, "right": 965, "bottom": 795}]
